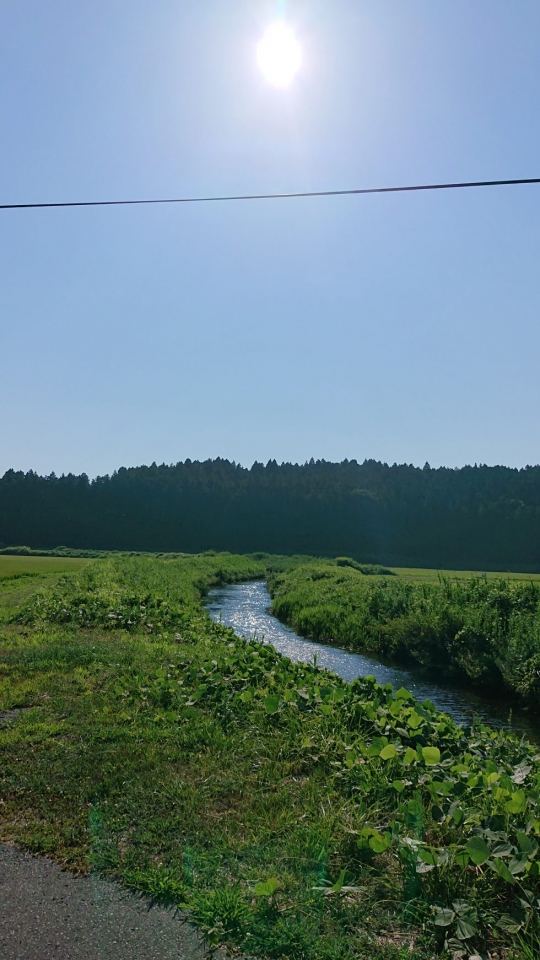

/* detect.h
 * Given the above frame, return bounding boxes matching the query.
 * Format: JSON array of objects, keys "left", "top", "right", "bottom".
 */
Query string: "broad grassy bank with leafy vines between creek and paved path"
[{"left": 0, "top": 555, "right": 540, "bottom": 960}]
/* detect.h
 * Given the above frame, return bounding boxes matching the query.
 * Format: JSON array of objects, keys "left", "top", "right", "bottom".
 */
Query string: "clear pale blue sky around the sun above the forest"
[{"left": 0, "top": 0, "right": 540, "bottom": 476}]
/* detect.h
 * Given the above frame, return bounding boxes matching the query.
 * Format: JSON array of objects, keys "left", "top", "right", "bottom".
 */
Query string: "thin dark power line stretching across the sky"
[{"left": 0, "top": 177, "right": 540, "bottom": 210}]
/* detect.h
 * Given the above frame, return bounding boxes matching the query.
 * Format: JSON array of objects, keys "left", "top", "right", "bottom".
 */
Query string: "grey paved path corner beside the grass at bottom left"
[{"left": 0, "top": 844, "right": 229, "bottom": 960}]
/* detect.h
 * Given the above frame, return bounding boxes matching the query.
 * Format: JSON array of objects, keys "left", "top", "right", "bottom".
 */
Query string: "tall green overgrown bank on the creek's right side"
[{"left": 270, "top": 562, "right": 540, "bottom": 709}]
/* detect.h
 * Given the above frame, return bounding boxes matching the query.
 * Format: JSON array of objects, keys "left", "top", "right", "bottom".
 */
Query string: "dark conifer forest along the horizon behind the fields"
[{"left": 0, "top": 458, "right": 540, "bottom": 572}]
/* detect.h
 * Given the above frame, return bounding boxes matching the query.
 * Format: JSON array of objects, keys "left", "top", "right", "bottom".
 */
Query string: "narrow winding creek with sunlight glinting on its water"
[{"left": 206, "top": 581, "right": 540, "bottom": 743}]
